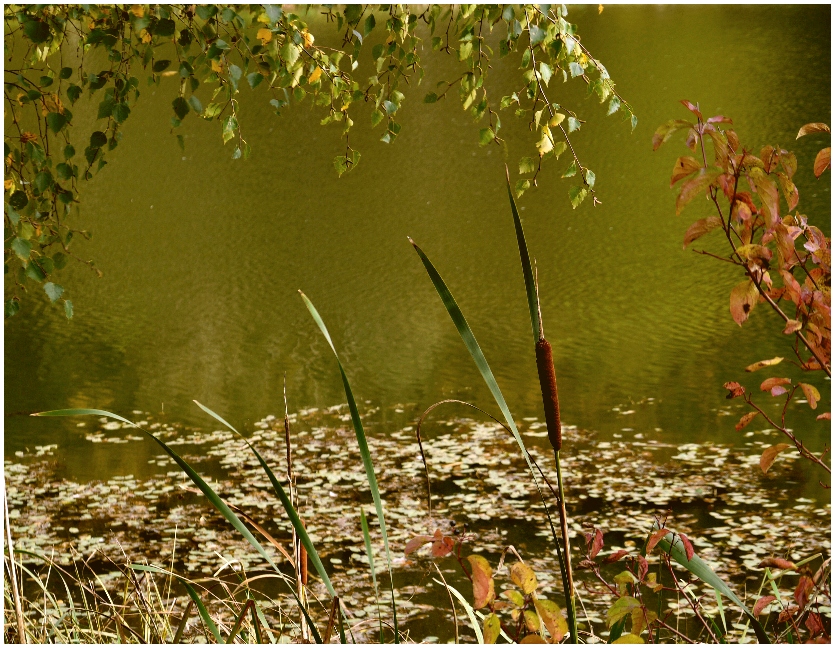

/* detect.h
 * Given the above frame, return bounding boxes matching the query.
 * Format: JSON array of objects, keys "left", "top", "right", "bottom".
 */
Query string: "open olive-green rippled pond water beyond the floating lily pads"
[{"left": 4, "top": 6, "right": 831, "bottom": 492}]
